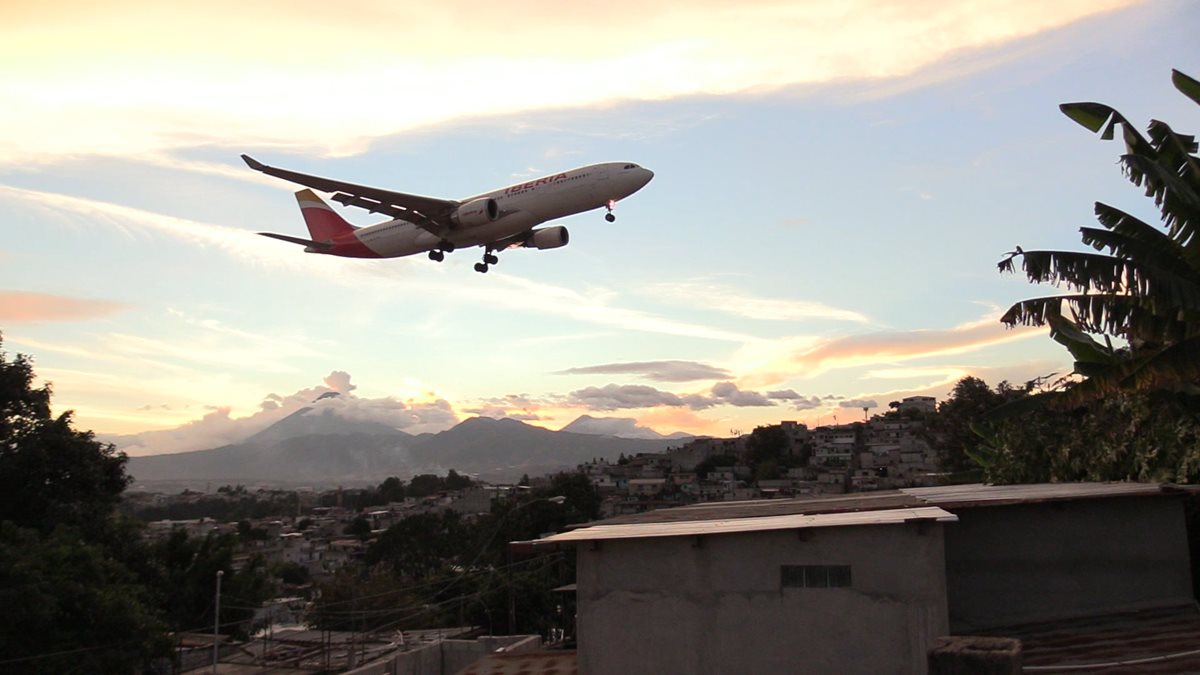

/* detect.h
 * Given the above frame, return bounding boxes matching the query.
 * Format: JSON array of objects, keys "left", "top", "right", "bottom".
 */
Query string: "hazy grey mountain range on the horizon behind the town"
[{"left": 127, "top": 407, "right": 690, "bottom": 486}]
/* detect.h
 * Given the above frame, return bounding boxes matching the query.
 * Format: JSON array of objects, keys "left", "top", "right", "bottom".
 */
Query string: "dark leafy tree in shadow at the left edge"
[{"left": 0, "top": 342, "right": 169, "bottom": 673}]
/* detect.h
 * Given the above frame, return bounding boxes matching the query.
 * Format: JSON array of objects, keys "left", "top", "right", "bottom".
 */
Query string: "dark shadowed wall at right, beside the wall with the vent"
[{"left": 946, "top": 497, "right": 1192, "bottom": 633}]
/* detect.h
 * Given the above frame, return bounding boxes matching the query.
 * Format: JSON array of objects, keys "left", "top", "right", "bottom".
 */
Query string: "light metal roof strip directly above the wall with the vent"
[{"left": 538, "top": 507, "right": 958, "bottom": 544}]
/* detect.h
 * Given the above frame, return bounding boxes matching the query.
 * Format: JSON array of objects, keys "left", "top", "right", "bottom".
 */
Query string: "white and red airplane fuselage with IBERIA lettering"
[{"left": 328, "top": 162, "right": 654, "bottom": 258}]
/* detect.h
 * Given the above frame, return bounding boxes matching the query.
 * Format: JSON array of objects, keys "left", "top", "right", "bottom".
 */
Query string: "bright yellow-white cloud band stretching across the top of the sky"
[{"left": 0, "top": 0, "right": 1135, "bottom": 162}]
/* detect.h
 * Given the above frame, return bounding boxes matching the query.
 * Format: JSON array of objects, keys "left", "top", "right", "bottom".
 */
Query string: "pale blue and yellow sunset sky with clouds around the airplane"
[{"left": 0, "top": 0, "right": 1200, "bottom": 454}]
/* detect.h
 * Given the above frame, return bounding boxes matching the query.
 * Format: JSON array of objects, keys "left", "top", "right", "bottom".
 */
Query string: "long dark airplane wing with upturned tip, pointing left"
[{"left": 241, "top": 155, "right": 460, "bottom": 237}]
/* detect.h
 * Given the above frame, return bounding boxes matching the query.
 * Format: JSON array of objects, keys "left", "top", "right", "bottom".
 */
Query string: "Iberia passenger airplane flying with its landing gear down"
[{"left": 241, "top": 155, "right": 654, "bottom": 273}]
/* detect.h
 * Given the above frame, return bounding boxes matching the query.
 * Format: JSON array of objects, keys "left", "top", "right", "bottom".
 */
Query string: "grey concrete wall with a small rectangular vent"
[{"left": 577, "top": 525, "right": 948, "bottom": 675}]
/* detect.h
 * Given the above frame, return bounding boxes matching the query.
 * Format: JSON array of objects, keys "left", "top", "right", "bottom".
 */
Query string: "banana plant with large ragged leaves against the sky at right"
[{"left": 998, "top": 71, "right": 1200, "bottom": 403}]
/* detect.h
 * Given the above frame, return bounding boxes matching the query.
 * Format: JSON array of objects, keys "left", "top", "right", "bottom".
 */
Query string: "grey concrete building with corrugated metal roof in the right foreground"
[{"left": 540, "top": 483, "right": 1198, "bottom": 675}]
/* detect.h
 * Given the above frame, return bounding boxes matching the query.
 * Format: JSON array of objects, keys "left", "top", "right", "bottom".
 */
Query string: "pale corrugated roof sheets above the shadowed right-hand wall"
[{"left": 900, "top": 483, "right": 1189, "bottom": 508}]
